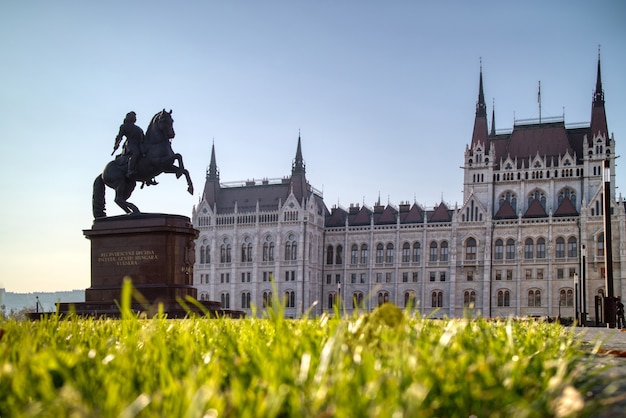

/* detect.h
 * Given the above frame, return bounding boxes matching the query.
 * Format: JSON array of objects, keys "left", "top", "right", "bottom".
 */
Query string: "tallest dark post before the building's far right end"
[{"left": 603, "top": 159, "right": 615, "bottom": 328}]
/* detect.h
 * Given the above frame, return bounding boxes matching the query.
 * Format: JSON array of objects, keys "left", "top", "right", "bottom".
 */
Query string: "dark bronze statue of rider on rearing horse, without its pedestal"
[{"left": 92, "top": 109, "right": 193, "bottom": 218}]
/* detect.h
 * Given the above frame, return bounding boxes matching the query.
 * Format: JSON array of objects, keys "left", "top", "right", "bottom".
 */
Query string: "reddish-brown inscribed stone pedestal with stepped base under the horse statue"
[{"left": 55, "top": 213, "right": 239, "bottom": 317}]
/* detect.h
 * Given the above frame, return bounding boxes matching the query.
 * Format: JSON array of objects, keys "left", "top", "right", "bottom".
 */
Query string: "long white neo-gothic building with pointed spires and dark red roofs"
[{"left": 193, "top": 60, "right": 626, "bottom": 321}]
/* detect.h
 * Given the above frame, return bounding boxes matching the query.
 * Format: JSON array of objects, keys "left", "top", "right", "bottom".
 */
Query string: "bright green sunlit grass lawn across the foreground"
[{"left": 0, "top": 290, "right": 612, "bottom": 417}]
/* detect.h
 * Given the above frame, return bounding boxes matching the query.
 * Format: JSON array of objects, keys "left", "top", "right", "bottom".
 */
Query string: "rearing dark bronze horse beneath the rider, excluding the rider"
[{"left": 92, "top": 109, "right": 193, "bottom": 218}]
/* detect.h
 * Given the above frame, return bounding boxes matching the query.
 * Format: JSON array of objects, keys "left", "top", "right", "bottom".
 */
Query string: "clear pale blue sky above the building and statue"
[{"left": 0, "top": 0, "right": 626, "bottom": 292}]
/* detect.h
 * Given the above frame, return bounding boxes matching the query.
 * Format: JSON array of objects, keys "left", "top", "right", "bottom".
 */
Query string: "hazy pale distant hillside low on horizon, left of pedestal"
[{"left": 0, "top": 288, "right": 85, "bottom": 315}]
